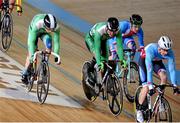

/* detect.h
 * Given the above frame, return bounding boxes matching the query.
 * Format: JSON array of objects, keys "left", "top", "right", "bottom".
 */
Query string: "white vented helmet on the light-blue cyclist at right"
[{"left": 158, "top": 36, "right": 172, "bottom": 50}]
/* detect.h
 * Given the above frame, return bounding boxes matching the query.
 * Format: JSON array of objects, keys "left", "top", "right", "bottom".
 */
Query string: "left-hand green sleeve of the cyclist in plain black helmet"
[{"left": 94, "top": 33, "right": 101, "bottom": 65}]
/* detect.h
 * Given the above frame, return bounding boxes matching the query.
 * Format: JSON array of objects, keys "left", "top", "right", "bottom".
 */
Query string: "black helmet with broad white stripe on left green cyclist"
[{"left": 44, "top": 14, "right": 57, "bottom": 30}]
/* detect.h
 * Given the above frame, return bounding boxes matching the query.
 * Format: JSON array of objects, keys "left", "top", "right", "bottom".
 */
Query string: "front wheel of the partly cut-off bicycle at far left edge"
[{"left": 1, "top": 14, "right": 13, "bottom": 52}]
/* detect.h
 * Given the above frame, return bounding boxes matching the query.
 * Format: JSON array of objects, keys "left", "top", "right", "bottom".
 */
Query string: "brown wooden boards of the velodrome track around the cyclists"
[{"left": 0, "top": 0, "right": 180, "bottom": 122}]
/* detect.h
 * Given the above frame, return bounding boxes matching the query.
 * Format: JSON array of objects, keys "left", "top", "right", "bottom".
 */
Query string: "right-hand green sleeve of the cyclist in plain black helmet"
[{"left": 116, "top": 32, "right": 124, "bottom": 61}]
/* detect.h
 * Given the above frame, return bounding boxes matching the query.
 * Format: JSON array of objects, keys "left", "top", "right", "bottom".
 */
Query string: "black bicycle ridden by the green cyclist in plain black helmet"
[{"left": 82, "top": 61, "right": 123, "bottom": 116}]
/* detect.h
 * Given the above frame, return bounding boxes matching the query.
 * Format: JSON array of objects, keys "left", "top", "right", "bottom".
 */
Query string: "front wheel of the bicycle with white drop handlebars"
[{"left": 37, "top": 62, "right": 50, "bottom": 104}]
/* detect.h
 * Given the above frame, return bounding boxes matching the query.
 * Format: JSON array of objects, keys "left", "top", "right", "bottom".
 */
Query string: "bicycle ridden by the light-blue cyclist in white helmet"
[{"left": 134, "top": 84, "right": 173, "bottom": 122}]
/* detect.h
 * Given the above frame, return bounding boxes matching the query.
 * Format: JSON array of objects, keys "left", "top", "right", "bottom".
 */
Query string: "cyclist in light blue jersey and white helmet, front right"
[{"left": 137, "top": 36, "right": 179, "bottom": 122}]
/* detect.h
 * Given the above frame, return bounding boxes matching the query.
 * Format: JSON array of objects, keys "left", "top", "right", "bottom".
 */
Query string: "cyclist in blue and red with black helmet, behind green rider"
[{"left": 108, "top": 14, "right": 144, "bottom": 59}]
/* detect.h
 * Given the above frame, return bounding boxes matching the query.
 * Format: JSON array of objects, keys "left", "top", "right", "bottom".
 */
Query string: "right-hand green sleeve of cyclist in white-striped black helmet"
[{"left": 53, "top": 28, "right": 60, "bottom": 55}]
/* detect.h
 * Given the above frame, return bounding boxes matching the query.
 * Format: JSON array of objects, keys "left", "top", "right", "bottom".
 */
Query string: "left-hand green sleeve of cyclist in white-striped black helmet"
[{"left": 28, "top": 29, "right": 37, "bottom": 57}]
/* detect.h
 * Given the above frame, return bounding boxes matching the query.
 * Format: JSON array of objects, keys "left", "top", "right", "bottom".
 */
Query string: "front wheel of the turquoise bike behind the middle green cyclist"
[{"left": 123, "top": 62, "right": 139, "bottom": 102}]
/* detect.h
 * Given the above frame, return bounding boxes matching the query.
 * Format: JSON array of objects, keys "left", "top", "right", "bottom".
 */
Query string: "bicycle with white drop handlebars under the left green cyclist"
[{"left": 26, "top": 51, "right": 60, "bottom": 104}]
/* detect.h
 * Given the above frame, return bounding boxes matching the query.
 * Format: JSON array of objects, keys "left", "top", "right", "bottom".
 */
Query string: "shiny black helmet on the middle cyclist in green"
[{"left": 107, "top": 17, "right": 119, "bottom": 32}]
